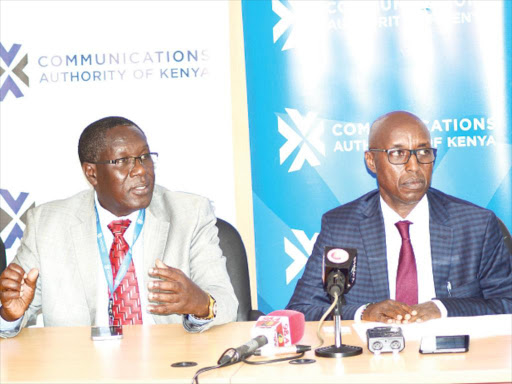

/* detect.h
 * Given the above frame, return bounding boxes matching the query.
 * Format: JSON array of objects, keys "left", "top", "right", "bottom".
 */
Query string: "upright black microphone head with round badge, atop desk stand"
[{"left": 322, "top": 247, "right": 357, "bottom": 297}]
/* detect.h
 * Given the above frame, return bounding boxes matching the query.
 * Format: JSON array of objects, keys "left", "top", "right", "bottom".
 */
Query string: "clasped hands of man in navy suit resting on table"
[{"left": 362, "top": 300, "right": 441, "bottom": 324}]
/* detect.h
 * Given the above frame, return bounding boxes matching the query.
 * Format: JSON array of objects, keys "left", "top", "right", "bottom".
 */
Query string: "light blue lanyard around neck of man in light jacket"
[{"left": 94, "top": 205, "right": 146, "bottom": 298}]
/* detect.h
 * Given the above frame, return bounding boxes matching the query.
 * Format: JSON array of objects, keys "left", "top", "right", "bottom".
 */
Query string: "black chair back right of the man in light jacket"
[{"left": 217, "top": 218, "right": 264, "bottom": 321}]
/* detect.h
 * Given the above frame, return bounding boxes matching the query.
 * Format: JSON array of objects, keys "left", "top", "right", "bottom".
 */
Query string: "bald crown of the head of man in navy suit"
[{"left": 368, "top": 111, "right": 430, "bottom": 148}]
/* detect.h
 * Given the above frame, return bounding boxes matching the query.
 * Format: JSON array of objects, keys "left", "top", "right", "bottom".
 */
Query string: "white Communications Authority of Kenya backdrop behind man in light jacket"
[{"left": 0, "top": 1, "right": 236, "bottom": 261}]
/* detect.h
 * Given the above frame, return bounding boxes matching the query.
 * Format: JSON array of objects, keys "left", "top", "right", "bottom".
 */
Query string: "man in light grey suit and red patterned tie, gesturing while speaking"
[{"left": 0, "top": 117, "right": 238, "bottom": 337}]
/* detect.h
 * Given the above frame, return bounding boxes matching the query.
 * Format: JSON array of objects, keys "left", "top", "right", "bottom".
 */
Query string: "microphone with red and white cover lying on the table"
[{"left": 218, "top": 310, "right": 306, "bottom": 365}]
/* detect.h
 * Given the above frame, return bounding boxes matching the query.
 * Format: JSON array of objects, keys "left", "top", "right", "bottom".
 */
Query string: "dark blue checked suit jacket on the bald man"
[{"left": 287, "top": 188, "right": 512, "bottom": 320}]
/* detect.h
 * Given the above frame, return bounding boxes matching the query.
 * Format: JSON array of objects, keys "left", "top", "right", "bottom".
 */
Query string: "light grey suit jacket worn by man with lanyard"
[{"left": 4, "top": 186, "right": 238, "bottom": 336}]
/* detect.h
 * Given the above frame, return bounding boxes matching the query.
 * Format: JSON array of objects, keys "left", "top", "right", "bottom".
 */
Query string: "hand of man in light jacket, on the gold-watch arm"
[{"left": 148, "top": 259, "right": 210, "bottom": 317}]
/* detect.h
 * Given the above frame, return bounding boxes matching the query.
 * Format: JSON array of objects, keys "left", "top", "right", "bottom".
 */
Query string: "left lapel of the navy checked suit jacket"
[{"left": 359, "top": 193, "right": 389, "bottom": 301}]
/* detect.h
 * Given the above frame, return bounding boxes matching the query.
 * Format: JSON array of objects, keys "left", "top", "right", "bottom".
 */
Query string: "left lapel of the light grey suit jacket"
[{"left": 70, "top": 191, "right": 100, "bottom": 324}]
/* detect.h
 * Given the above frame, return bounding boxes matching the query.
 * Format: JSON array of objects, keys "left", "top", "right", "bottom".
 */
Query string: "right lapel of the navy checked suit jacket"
[{"left": 427, "top": 191, "right": 453, "bottom": 298}]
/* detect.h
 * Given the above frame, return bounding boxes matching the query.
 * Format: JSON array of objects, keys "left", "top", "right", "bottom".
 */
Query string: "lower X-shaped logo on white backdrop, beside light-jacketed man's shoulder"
[{"left": 0, "top": 189, "right": 35, "bottom": 249}]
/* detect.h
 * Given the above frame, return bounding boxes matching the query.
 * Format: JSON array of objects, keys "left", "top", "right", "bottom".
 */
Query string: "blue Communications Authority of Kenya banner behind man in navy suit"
[{"left": 242, "top": 0, "right": 512, "bottom": 312}]
